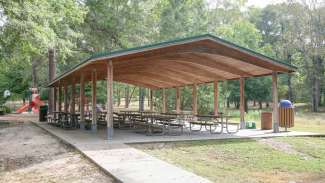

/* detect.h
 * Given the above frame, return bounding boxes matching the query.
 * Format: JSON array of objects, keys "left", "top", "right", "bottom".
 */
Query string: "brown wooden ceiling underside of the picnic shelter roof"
[{"left": 53, "top": 40, "right": 290, "bottom": 89}]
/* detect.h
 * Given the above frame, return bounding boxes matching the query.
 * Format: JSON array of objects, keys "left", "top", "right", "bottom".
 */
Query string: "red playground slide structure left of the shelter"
[{"left": 16, "top": 88, "right": 44, "bottom": 113}]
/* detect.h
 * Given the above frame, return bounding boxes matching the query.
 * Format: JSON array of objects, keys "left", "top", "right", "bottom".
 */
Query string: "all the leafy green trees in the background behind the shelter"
[{"left": 0, "top": 0, "right": 325, "bottom": 113}]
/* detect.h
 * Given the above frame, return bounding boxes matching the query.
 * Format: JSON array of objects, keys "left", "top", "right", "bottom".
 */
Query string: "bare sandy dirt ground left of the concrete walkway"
[{"left": 0, "top": 119, "right": 114, "bottom": 183}]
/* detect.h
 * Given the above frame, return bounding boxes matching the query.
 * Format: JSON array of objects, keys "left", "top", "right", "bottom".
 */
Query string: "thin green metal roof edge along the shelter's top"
[{"left": 49, "top": 34, "right": 297, "bottom": 85}]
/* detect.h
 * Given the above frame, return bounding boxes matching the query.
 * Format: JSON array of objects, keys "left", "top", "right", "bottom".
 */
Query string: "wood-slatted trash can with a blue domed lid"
[{"left": 279, "top": 100, "right": 294, "bottom": 131}]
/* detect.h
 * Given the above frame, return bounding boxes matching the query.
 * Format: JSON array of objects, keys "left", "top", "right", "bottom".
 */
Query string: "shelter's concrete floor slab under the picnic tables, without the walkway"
[{"left": 37, "top": 123, "right": 320, "bottom": 144}]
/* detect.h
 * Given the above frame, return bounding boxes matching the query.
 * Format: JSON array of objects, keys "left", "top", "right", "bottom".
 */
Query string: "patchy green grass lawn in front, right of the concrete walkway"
[{"left": 134, "top": 137, "right": 325, "bottom": 183}]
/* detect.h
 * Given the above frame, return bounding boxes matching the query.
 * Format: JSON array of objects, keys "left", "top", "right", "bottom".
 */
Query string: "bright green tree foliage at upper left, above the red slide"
[{"left": 0, "top": 0, "right": 86, "bottom": 96}]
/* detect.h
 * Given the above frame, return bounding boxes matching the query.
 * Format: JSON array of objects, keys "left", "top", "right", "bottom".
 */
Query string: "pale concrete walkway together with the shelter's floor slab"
[{"left": 34, "top": 122, "right": 317, "bottom": 183}]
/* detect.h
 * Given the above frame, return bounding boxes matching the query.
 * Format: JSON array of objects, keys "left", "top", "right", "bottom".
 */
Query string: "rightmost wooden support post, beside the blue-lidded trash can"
[{"left": 272, "top": 72, "right": 279, "bottom": 133}]
